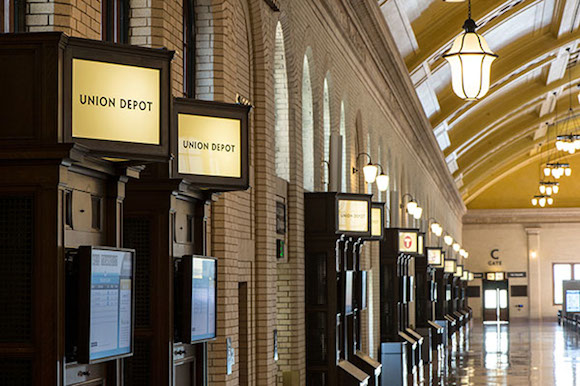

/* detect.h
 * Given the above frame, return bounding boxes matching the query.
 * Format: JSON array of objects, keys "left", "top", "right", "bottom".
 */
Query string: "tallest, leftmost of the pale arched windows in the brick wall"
[{"left": 274, "top": 22, "right": 290, "bottom": 181}]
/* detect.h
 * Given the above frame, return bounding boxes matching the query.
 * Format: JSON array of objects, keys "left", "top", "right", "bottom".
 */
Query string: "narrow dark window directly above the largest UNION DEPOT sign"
[{"left": 101, "top": 0, "right": 130, "bottom": 43}]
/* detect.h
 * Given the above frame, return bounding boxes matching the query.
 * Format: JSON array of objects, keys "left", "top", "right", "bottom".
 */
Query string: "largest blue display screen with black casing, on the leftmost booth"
[{"left": 77, "top": 246, "right": 135, "bottom": 363}]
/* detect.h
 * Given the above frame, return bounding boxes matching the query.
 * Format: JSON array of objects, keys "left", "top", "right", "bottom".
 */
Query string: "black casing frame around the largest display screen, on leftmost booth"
[{"left": 77, "top": 246, "right": 136, "bottom": 364}]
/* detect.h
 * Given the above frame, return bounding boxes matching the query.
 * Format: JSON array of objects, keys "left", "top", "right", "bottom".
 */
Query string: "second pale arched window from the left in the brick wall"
[{"left": 302, "top": 55, "right": 314, "bottom": 192}]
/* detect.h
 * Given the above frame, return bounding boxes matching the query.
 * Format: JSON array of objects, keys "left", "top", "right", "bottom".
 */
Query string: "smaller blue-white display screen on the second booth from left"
[{"left": 191, "top": 256, "right": 217, "bottom": 342}]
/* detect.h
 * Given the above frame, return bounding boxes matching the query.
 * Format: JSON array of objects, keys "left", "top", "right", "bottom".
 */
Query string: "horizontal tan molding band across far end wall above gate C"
[{"left": 463, "top": 208, "right": 580, "bottom": 225}]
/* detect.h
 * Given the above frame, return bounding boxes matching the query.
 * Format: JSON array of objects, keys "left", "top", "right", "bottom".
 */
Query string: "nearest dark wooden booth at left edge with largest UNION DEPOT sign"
[{"left": 0, "top": 32, "right": 173, "bottom": 386}]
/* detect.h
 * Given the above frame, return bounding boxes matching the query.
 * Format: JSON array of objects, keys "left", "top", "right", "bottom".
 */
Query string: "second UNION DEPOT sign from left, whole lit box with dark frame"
[{"left": 171, "top": 99, "right": 250, "bottom": 190}]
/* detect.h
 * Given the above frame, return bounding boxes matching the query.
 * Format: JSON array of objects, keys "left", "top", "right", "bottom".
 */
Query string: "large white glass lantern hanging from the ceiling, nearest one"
[{"left": 443, "top": 0, "right": 497, "bottom": 100}]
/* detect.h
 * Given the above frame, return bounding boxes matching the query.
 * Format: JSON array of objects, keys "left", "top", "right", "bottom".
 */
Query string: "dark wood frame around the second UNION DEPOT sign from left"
[{"left": 171, "top": 98, "right": 251, "bottom": 192}]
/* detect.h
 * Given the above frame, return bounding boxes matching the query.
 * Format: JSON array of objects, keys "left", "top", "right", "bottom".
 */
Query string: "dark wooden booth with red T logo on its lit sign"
[{"left": 380, "top": 228, "right": 425, "bottom": 386}]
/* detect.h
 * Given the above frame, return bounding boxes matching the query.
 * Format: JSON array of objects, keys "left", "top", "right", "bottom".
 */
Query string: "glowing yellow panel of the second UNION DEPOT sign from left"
[{"left": 177, "top": 114, "right": 242, "bottom": 178}]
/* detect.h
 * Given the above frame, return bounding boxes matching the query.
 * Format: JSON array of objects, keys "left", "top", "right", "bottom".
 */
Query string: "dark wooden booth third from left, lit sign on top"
[{"left": 304, "top": 192, "right": 382, "bottom": 386}]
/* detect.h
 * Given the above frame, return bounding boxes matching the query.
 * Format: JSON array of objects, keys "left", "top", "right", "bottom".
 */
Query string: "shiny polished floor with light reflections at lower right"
[{"left": 440, "top": 321, "right": 580, "bottom": 386}]
